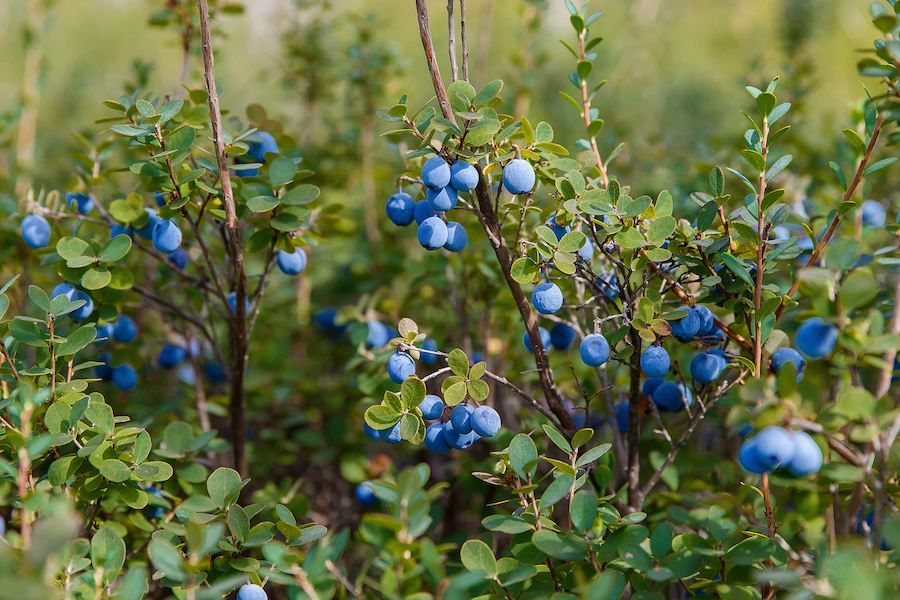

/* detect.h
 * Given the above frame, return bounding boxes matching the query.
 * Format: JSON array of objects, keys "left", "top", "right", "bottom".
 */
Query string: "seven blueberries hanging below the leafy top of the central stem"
[{"left": 385, "top": 156, "right": 535, "bottom": 252}]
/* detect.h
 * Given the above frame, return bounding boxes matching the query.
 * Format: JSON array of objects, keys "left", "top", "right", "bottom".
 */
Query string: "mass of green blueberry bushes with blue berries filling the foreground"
[{"left": 0, "top": 0, "right": 900, "bottom": 600}]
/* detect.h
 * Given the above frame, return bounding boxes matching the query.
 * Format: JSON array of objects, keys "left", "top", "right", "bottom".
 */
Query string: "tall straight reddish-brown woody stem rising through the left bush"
[{"left": 198, "top": 0, "right": 249, "bottom": 478}]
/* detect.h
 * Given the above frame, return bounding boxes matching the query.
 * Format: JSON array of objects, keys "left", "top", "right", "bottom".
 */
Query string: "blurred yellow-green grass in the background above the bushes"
[{"left": 0, "top": 0, "right": 873, "bottom": 189}]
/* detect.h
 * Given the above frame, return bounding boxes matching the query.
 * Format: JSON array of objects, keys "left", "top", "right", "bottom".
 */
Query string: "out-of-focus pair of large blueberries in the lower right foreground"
[{"left": 738, "top": 425, "right": 822, "bottom": 477}]
